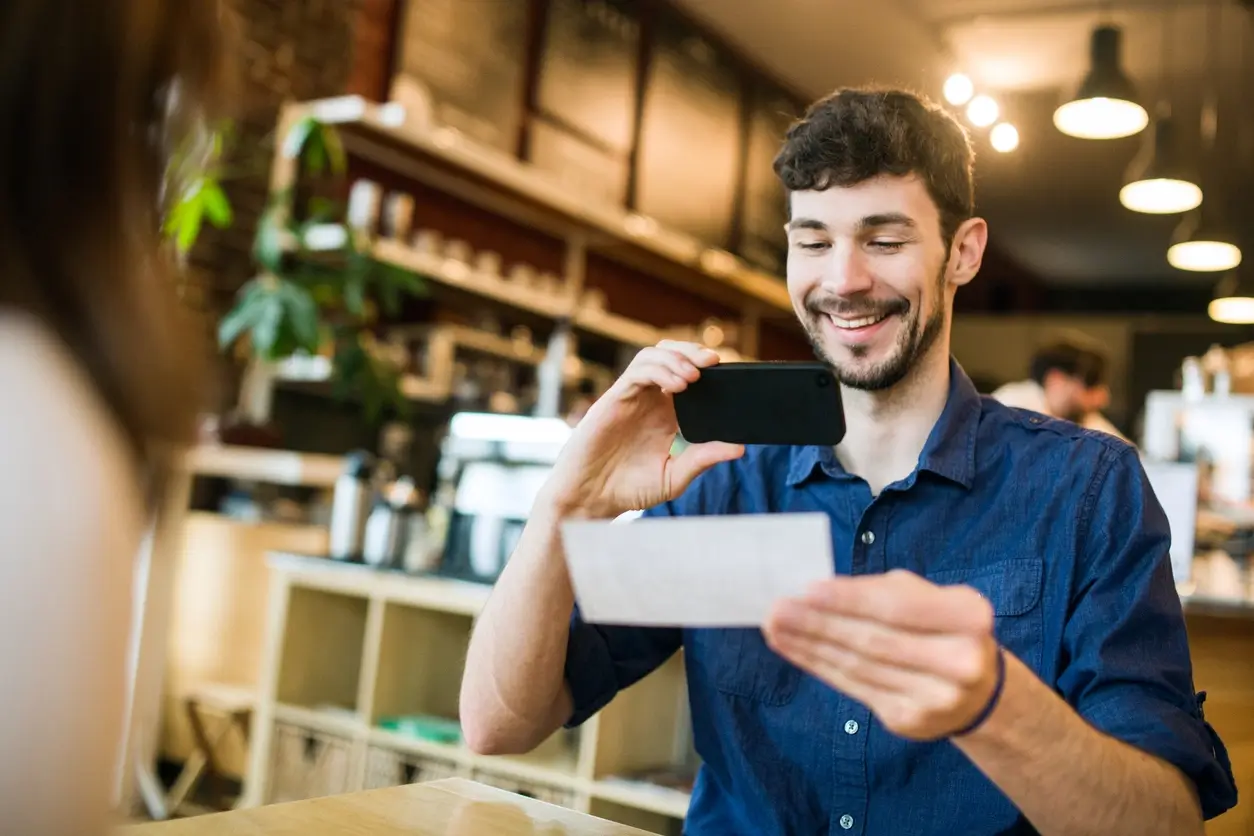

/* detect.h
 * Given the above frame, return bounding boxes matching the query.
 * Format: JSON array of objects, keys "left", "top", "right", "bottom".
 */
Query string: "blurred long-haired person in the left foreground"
[{"left": 0, "top": 0, "right": 221, "bottom": 836}]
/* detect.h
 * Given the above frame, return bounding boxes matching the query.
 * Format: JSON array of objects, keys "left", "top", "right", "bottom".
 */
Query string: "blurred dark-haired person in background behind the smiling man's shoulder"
[{"left": 993, "top": 340, "right": 1127, "bottom": 441}]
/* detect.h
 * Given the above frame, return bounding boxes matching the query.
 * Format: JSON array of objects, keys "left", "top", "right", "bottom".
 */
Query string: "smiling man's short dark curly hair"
[{"left": 775, "top": 89, "right": 976, "bottom": 246}]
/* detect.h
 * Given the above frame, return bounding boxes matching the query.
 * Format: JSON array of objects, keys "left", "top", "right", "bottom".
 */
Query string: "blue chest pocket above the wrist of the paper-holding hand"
[{"left": 928, "top": 558, "right": 1045, "bottom": 672}]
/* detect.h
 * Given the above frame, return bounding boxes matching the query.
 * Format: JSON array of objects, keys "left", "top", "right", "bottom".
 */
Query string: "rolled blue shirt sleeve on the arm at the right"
[{"left": 1058, "top": 445, "right": 1236, "bottom": 818}]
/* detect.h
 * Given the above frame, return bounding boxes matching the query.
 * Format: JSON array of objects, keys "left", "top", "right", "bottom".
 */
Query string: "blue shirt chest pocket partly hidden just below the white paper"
[{"left": 686, "top": 628, "right": 801, "bottom": 706}]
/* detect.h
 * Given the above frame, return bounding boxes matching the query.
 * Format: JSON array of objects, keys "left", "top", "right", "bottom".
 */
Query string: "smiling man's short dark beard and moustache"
[{"left": 805, "top": 266, "right": 944, "bottom": 392}]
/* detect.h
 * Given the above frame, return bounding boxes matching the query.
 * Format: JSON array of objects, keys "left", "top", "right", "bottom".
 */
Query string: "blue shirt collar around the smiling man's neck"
[{"left": 788, "top": 358, "right": 981, "bottom": 490}]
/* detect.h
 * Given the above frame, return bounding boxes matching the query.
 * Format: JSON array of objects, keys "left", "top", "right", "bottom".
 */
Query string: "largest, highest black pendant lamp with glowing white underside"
[{"left": 1053, "top": 26, "right": 1150, "bottom": 139}]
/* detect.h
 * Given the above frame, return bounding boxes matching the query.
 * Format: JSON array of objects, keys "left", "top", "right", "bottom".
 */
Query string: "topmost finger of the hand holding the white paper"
[{"left": 804, "top": 569, "right": 993, "bottom": 634}]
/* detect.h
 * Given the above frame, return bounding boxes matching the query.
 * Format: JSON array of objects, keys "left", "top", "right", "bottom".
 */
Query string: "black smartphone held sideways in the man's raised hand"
[{"left": 675, "top": 362, "right": 845, "bottom": 446}]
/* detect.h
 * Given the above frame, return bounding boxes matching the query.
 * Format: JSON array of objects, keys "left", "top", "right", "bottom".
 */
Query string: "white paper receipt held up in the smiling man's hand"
[{"left": 562, "top": 514, "right": 833, "bottom": 627}]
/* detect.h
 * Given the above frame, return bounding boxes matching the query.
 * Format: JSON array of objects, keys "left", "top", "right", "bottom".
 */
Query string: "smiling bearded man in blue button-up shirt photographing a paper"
[{"left": 461, "top": 90, "right": 1235, "bottom": 836}]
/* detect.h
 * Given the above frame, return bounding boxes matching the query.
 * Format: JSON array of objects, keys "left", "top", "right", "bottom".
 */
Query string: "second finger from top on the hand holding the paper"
[{"left": 770, "top": 600, "right": 989, "bottom": 686}]
